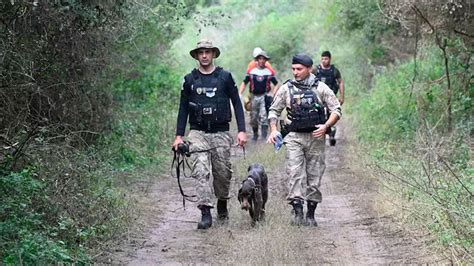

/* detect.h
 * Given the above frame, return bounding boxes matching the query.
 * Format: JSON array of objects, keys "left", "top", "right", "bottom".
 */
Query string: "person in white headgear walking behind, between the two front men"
[{"left": 239, "top": 49, "right": 278, "bottom": 141}]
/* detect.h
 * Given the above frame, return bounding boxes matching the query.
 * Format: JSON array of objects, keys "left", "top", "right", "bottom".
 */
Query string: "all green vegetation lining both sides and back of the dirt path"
[{"left": 0, "top": 0, "right": 474, "bottom": 264}]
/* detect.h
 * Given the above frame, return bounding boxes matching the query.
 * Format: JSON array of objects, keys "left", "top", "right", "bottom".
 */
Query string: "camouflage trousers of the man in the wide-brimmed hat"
[{"left": 188, "top": 130, "right": 233, "bottom": 207}]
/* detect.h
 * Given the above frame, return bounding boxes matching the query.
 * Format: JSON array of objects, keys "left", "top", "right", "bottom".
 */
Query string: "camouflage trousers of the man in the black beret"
[{"left": 284, "top": 132, "right": 326, "bottom": 202}]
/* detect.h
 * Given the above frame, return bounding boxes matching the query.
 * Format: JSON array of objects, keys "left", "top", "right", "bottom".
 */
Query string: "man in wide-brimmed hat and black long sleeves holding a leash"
[{"left": 173, "top": 39, "right": 247, "bottom": 229}]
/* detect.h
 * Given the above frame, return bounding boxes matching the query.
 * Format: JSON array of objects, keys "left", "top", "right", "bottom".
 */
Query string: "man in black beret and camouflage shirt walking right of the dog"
[{"left": 267, "top": 54, "right": 342, "bottom": 226}]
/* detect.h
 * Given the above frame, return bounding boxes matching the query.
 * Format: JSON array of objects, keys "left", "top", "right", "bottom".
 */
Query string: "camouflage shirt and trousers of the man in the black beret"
[{"left": 268, "top": 74, "right": 341, "bottom": 202}]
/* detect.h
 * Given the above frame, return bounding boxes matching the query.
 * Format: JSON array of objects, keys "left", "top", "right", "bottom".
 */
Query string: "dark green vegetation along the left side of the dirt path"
[{"left": 0, "top": 1, "right": 195, "bottom": 264}]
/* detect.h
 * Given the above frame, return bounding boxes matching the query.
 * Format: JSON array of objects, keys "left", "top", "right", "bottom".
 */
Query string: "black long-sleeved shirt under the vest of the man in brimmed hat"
[{"left": 176, "top": 67, "right": 245, "bottom": 136}]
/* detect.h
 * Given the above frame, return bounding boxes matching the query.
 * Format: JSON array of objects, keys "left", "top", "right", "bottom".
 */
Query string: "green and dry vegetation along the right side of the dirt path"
[{"left": 330, "top": 1, "right": 474, "bottom": 261}]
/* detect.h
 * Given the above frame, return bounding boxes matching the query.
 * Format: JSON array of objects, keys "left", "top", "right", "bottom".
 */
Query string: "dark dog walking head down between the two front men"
[{"left": 237, "top": 163, "right": 268, "bottom": 225}]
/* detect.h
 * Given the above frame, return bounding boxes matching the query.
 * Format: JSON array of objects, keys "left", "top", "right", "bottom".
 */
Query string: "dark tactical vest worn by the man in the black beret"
[{"left": 287, "top": 82, "right": 327, "bottom": 132}]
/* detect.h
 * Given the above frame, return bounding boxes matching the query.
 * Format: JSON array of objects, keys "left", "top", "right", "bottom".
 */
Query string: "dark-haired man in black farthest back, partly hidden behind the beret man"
[{"left": 313, "top": 51, "right": 344, "bottom": 146}]
